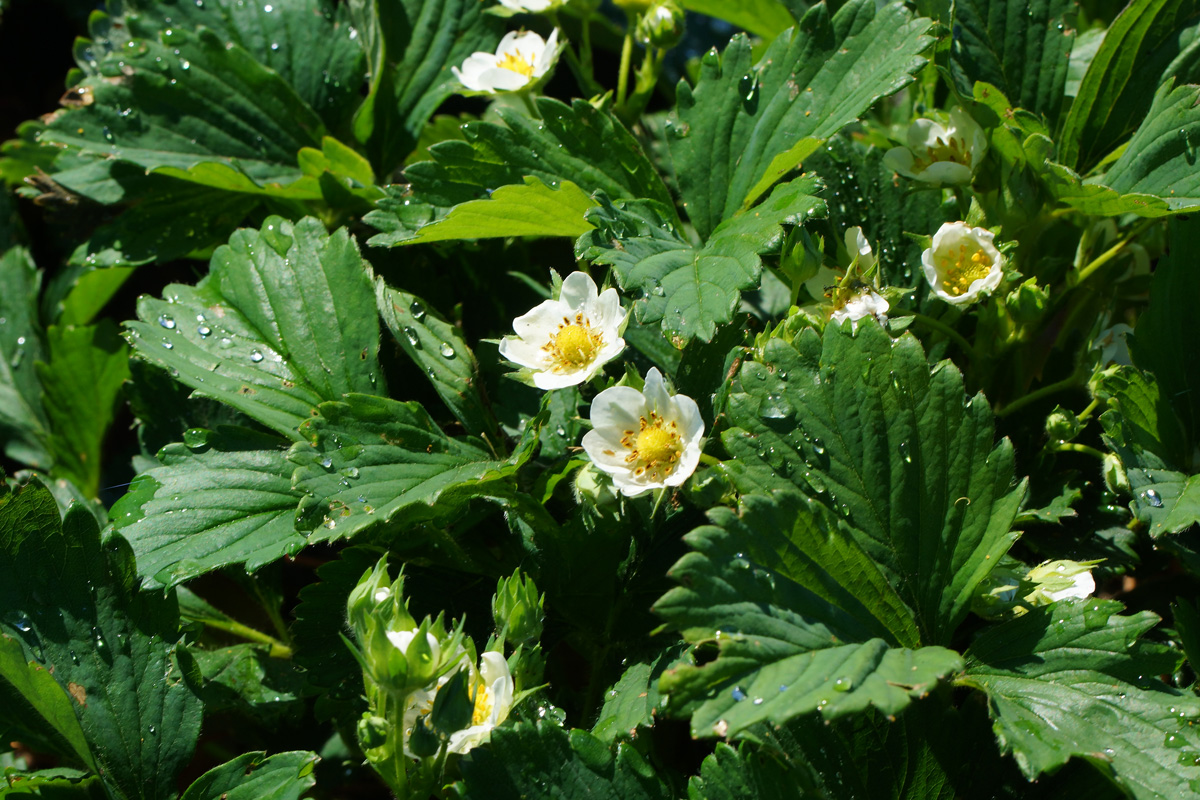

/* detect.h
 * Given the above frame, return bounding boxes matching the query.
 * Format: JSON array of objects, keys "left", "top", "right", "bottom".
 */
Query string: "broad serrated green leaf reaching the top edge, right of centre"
[{"left": 672, "top": 0, "right": 932, "bottom": 237}]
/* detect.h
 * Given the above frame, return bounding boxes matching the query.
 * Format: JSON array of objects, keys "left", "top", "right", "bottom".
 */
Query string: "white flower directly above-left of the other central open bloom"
[{"left": 500, "top": 272, "right": 629, "bottom": 389}]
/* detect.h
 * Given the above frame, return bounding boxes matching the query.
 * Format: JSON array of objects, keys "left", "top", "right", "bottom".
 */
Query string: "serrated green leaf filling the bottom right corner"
[{"left": 960, "top": 600, "right": 1200, "bottom": 800}]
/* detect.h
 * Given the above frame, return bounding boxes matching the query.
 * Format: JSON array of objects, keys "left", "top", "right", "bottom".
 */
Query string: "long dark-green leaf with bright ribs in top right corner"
[{"left": 1058, "top": 0, "right": 1200, "bottom": 173}]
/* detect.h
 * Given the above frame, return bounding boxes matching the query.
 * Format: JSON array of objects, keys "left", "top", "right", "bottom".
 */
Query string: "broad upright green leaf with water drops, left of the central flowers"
[{"left": 126, "top": 217, "right": 384, "bottom": 439}]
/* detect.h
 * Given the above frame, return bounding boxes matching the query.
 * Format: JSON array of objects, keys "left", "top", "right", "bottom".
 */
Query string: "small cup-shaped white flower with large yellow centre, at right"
[{"left": 920, "top": 222, "right": 1004, "bottom": 306}]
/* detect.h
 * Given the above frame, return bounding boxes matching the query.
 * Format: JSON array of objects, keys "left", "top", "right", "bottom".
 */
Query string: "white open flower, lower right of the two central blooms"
[{"left": 583, "top": 368, "right": 704, "bottom": 497}]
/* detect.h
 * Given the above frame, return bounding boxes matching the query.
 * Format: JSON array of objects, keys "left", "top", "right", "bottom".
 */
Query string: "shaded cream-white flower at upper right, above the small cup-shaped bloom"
[{"left": 883, "top": 108, "right": 988, "bottom": 185}]
